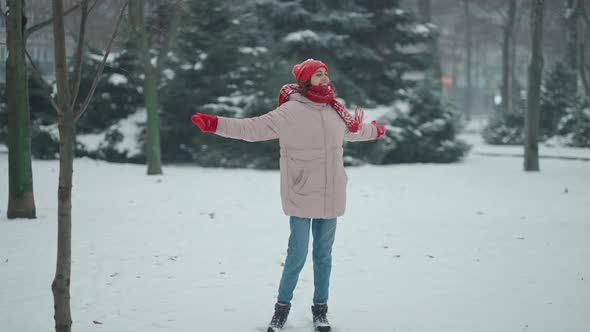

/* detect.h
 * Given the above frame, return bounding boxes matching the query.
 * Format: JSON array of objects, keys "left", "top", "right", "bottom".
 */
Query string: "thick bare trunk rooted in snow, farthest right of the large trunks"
[{"left": 524, "top": 0, "right": 545, "bottom": 171}]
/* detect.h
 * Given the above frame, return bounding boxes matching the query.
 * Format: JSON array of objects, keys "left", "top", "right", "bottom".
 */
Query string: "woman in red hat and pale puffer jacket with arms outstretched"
[{"left": 192, "top": 59, "right": 385, "bottom": 332}]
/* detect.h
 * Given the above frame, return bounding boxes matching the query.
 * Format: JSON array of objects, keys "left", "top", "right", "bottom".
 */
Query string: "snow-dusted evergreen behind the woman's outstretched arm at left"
[{"left": 162, "top": 0, "right": 278, "bottom": 168}]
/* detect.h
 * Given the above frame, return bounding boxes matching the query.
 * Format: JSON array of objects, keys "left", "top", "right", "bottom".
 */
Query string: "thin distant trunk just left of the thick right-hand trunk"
[{"left": 501, "top": 0, "right": 516, "bottom": 112}]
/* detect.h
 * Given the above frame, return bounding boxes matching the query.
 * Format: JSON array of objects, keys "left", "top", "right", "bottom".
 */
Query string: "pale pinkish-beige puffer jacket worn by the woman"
[{"left": 215, "top": 93, "right": 377, "bottom": 218}]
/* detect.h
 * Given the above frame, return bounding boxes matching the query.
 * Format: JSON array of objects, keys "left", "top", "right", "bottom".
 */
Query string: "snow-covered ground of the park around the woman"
[{"left": 0, "top": 141, "right": 590, "bottom": 332}]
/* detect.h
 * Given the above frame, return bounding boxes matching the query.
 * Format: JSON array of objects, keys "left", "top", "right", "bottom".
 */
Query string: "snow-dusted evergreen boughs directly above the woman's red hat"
[{"left": 259, "top": 0, "right": 434, "bottom": 106}]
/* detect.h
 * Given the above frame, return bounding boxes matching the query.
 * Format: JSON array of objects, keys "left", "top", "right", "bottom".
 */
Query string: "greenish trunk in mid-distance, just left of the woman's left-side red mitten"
[{"left": 129, "top": 0, "right": 166, "bottom": 175}]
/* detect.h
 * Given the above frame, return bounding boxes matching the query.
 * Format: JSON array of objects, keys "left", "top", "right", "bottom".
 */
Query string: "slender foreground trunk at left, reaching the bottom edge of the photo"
[{"left": 51, "top": 0, "right": 75, "bottom": 332}]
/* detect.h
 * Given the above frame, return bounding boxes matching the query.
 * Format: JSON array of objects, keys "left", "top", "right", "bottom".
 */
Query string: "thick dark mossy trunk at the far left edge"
[{"left": 6, "top": 0, "right": 36, "bottom": 219}]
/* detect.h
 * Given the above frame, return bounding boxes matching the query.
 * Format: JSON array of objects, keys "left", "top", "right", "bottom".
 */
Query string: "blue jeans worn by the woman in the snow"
[{"left": 278, "top": 217, "right": 336, "bottom": 304}]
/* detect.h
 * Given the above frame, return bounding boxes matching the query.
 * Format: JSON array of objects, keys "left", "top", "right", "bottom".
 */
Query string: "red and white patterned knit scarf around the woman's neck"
[{"left": 278, "top": 84, "right": 364, "bottom": 133}]
